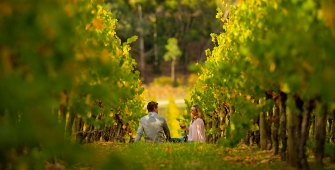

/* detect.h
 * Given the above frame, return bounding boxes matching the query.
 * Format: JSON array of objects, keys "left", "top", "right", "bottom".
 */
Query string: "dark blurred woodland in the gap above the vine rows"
[{"left": 105, "top": 0, "right": 222, "bottom": 80}]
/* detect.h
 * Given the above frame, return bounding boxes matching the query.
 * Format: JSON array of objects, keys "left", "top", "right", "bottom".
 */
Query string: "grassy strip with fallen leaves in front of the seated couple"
[{"left": 86, "top": 142, "right": 288, "bottom": 170}]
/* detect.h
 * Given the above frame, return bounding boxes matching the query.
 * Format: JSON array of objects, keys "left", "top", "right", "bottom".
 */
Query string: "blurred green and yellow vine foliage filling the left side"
[{"left": 0, "top": 0, "right": 144, "bottom": 169}]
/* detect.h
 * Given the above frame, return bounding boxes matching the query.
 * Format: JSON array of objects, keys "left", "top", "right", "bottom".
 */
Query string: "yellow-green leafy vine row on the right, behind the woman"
[{"left": 187, "top": 0, "right": 335, "bottom": 169}]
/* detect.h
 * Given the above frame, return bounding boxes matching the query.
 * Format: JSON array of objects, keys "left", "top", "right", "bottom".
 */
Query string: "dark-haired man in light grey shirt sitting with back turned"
[{"left": 135, "top": 101, "right": 171, "bottom": 142}]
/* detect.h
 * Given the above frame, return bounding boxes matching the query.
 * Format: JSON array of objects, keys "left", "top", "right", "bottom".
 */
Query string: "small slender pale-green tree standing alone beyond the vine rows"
[{"left": 163, "top": 38, "right": 182, "bottom": 85}]
